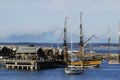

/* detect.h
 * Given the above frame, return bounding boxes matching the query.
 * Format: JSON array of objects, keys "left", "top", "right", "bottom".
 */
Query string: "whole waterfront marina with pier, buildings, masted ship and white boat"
[{"left": 0, "top": 12, "right": 120, "bottom": 70}]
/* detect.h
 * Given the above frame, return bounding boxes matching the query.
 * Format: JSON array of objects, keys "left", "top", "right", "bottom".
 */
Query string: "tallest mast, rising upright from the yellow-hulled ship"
[{"left": 80, "top": 12, "right": 84, "bottom": 58}]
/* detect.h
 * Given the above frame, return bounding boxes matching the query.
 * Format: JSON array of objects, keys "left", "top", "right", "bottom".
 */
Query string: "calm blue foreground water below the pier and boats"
[{"left": 0, "top": 61, "right": 120, "bottom": 80}]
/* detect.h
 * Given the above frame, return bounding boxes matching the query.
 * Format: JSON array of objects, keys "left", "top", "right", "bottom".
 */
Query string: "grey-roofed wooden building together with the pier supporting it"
[{"left": 4, "top": 46, "right": 54, "bottom": 71}]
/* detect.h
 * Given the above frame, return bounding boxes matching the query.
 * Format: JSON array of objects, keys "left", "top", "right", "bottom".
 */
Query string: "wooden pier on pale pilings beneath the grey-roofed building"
[{"left": 0, "top": 59, "right": 56, "bottom": 71}]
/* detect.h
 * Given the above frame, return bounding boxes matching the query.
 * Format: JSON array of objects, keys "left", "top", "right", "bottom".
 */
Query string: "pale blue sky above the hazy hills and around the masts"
[{"left": 0, "top": 0, "right": 120, "bottom": 43}]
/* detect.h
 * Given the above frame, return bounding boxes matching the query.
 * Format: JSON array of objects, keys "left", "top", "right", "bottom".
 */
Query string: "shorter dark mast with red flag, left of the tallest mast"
[{"left": 63, "top": 17, "right": 68, "bottom": 62}]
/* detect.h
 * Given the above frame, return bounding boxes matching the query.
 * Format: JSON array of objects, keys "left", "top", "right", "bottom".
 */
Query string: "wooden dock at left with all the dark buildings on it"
[{"left": 0, "top": 46, "right": 62, "bottom": 71}]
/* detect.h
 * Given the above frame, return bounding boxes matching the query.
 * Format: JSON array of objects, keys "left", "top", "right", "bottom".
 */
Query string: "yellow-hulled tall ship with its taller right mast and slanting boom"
[{"left": 67, "top": 12, "right": 101, "bottom": 67}]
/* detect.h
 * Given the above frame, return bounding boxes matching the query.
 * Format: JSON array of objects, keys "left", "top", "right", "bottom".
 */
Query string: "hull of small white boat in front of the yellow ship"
[{"left": 65, "top": 65, "right": 83, "bottom": 74}]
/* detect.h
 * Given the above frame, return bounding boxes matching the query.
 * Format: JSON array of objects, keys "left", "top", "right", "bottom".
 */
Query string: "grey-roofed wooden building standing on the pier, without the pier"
[{"left": 16, "top": 46, "right": 47, "bottom": 60}]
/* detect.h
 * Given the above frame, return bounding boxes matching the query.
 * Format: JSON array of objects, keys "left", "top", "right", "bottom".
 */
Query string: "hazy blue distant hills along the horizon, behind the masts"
[{"left": 0, "top": 31, "right": 111, "bottom": 43}]
